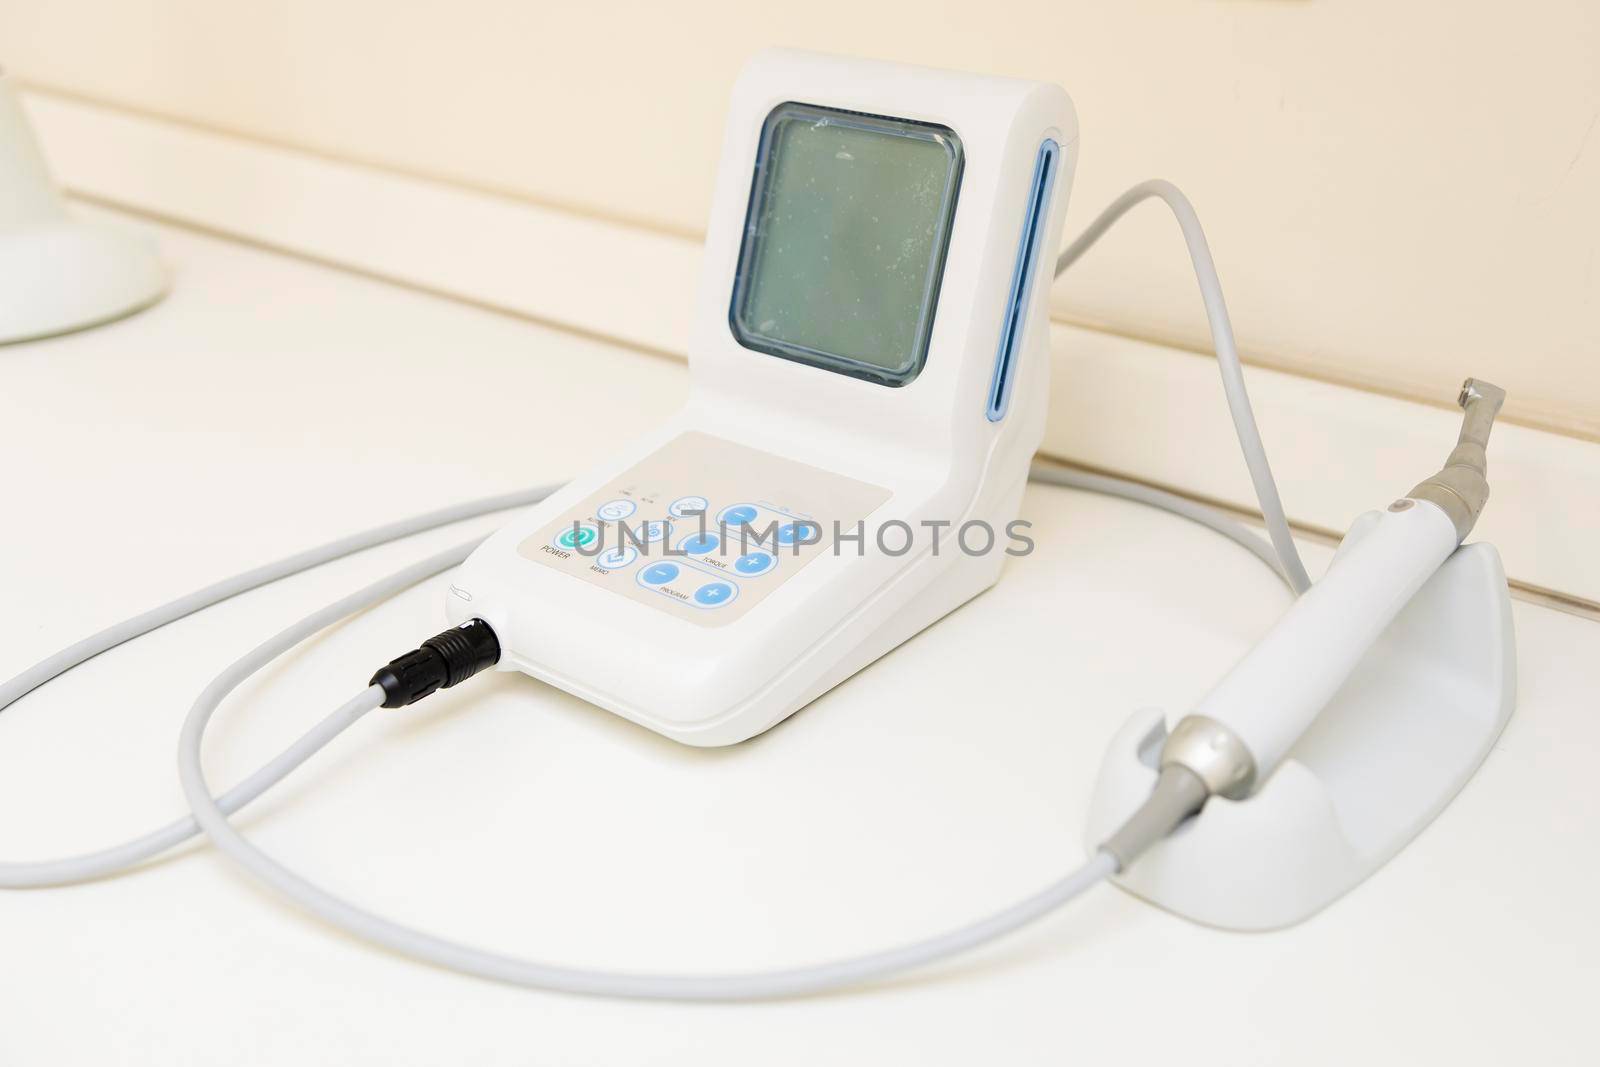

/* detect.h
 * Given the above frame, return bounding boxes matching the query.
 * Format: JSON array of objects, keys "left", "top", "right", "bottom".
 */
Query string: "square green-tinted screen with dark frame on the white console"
[{"left": 731, "top": 104, "right": 962, "bottom": 386}]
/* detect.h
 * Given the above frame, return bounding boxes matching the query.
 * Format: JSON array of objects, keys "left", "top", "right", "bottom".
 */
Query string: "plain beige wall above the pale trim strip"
[{"left": 0, "top": 0, "right": 1600, "bottom": 437}]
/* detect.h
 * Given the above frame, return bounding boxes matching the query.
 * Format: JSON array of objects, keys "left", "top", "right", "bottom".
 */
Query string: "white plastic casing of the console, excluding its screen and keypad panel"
[{"left": 446, "top": 51, "right": 1077, "bottom": 745}]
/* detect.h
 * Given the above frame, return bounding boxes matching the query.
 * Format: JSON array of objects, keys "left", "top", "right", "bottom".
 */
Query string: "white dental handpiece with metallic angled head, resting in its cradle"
[{"left": 1102, "top": 378, "right": 1506, "bottom": 865}]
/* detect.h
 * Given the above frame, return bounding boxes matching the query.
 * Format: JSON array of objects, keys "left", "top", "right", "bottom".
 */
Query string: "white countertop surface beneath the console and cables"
[{"left": 0, "top": 211, "right": 1600, "bottom": 1065}]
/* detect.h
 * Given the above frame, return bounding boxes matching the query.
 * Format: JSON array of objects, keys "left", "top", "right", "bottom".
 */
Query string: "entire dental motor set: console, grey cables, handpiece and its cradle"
[{"left": 0, "top": 51, "right": 1515, "bottom": 1000}]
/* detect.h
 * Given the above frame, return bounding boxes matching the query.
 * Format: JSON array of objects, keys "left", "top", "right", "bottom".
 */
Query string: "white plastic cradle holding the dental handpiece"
[{"left": 1086, "top": 512, "right": 1517, "bottom": 929}]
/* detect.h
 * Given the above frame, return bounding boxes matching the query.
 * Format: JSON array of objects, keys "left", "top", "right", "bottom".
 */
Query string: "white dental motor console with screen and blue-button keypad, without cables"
[{"left": 450, "top": 54, "right": 1077, "bottom": 745}]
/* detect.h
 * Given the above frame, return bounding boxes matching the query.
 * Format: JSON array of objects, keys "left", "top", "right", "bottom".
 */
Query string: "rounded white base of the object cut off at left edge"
[{"left": 0, "top": 219, "right": 168, "bottom": 344}]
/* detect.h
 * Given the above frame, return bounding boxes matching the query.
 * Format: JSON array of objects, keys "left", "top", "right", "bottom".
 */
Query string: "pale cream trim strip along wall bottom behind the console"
[{"left": 26, "top": 91, "right": 1600, "bottom": 609}]
